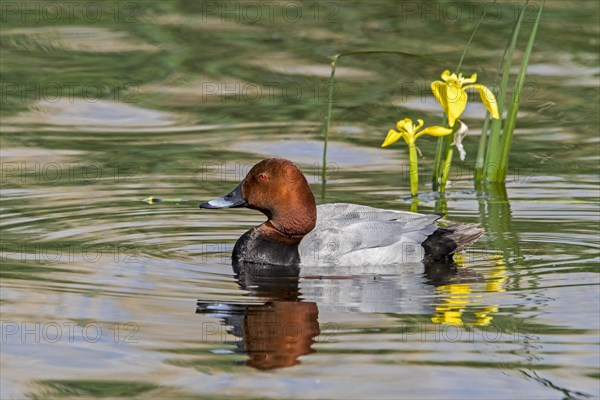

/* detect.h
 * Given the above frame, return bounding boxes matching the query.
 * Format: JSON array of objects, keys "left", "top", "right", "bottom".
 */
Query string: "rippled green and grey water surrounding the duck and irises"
[{"left": 0, "top": 0, "right": 600, "bottom": 399}]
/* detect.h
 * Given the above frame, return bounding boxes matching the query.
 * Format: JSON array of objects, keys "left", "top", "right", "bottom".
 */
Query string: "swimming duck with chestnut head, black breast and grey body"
[{"left": 199, "top": 158, "right": 483, "bottom": 268}]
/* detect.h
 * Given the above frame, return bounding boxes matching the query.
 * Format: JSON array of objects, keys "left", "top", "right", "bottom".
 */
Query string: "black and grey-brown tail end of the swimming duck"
[{"left": 422, "top": 223, "right": 483, "bottom": 262}]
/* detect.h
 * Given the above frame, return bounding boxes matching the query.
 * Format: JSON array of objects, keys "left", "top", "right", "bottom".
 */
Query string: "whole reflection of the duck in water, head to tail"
[{"left": 196, "top": 261, "right": 482, "bottom": 370}]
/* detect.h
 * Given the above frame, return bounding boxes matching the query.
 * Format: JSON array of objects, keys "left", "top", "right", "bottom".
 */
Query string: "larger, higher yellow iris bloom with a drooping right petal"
[{"left": 431, "top": 70, "right": 500, "bottom": 126}]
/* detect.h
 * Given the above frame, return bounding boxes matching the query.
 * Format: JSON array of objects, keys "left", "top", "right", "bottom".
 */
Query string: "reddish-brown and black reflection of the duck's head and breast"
[{"left": 196, "top": 263, "right": 320, "bottom": 370}]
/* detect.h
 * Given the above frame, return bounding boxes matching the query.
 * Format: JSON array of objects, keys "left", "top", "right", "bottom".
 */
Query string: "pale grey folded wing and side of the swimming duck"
[{"left": 299, "top": 203, "right": 440, "bottom": 264}]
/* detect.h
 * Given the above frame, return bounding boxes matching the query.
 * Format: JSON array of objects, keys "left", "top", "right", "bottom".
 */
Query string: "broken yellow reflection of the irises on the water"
[{"left": 431, "top": 257, "right": 508, "bottom": 326}]
